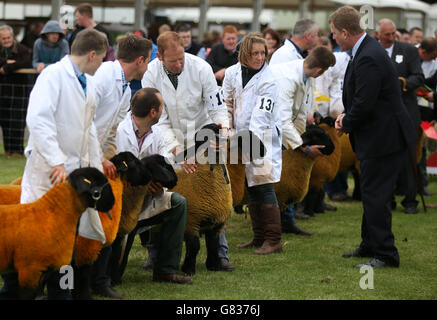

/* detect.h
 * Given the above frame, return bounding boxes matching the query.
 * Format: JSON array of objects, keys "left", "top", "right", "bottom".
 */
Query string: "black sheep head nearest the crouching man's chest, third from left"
[{"left": 141, "top": 154, "right": 178, "bottom": 189}]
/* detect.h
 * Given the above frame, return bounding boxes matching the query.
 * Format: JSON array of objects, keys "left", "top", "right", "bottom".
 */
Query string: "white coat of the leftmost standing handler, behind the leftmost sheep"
[{"left": 21, "top": 56, "right": 102, "bottom": 203}]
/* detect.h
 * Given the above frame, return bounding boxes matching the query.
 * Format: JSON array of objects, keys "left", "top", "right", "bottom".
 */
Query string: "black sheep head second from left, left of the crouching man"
[{"left": 111, "top": 151, "right": 152, "bottom": 186}]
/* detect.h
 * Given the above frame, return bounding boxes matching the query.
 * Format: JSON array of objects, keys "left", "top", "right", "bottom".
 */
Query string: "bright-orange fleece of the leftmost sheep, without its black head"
[{"left": 0, "top": 182, "right": 86, "bottom": 288}]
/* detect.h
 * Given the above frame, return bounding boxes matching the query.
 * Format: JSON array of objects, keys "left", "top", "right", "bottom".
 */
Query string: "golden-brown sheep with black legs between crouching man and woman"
[{"left": 170, "top": 124, "right": 263, "bottom": 275}]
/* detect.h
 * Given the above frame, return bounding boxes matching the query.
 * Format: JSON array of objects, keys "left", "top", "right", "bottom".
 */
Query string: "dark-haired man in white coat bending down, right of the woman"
[{"left": 271, "top": 46, "right": 335, "bottom": 228}]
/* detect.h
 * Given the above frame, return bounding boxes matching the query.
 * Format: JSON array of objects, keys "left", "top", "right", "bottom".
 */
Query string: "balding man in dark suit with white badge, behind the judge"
[{"left": 375, "top": 19, "right": 425, "bottom": 214}]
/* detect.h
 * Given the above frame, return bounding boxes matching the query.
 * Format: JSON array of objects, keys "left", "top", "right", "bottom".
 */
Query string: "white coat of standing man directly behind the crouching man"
[{"left": 141, "top": 53, "right": 229, "bottom": 149}]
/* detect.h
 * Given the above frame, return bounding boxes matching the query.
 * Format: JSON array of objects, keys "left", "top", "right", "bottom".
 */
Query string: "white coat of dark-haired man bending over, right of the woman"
[{"left": 271, "top": 60, "right": 314, "bottom": 149}]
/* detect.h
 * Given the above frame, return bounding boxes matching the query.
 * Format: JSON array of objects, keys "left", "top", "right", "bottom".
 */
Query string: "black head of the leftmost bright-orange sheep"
[{"left": 67, "top": 167, "right": 115, "bottom": 212}]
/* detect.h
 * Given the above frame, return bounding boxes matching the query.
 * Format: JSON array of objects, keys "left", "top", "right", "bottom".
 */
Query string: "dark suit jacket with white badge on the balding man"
[{"left": 391, "top": 41, "right": 425, "bottom": 127}]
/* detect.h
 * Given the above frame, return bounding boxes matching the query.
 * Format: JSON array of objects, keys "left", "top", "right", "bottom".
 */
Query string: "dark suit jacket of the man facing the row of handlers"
[{"left": 342, "top": 35, "right": 416, "bottom": 160}]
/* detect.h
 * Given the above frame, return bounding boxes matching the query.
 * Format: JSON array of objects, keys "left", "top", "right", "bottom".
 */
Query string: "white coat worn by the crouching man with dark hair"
[{"left": 116, "top": 112, "right": 172, "bottom": 220}]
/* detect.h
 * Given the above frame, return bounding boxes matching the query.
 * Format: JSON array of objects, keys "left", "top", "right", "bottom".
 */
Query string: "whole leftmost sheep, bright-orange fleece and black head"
[{"left": 0, "top": 168, "right": 115, "bottom": 298}]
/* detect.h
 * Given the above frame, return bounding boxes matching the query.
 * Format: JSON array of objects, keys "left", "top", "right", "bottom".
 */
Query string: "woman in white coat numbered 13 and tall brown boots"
[{"left": 223, "top": 34, "right": 282, "bottom": 254}]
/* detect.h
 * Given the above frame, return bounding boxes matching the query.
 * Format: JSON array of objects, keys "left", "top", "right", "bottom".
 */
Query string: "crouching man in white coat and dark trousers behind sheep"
[{"left": 111, "top": 88, "right": 192, "bottom": 284}]
